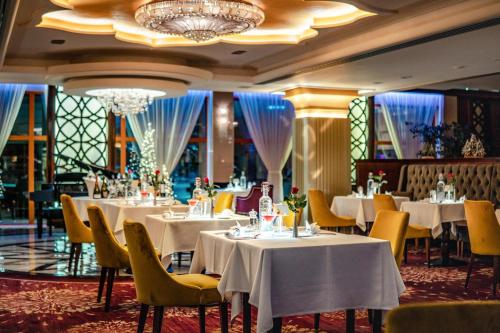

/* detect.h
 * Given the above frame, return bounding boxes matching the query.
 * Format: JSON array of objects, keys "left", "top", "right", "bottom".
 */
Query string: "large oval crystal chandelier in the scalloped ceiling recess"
[{"left": 135, "top": 0, "right": 265, "bottom": 42}]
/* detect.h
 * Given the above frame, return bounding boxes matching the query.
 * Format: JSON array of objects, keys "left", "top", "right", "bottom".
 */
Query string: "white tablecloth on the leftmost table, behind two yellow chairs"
[{"left": 73, "top": 197, "right": 187, "bottom": 242}]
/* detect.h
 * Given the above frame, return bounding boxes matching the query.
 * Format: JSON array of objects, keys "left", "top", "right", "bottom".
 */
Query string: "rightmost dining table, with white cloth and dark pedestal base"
[{"left": 400, "top": 200, "right": 466, "bottom": 266}]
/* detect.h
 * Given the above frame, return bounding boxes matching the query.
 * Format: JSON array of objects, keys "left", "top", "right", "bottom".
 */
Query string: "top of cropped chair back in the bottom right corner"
[{"left": 385, "top": 301, "right": 500, "bottom": 333}]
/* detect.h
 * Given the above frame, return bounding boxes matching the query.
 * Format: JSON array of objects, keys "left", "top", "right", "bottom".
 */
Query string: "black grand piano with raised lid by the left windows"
[{"left": 29, "top": 155, "right": 117, "bottom": 238}]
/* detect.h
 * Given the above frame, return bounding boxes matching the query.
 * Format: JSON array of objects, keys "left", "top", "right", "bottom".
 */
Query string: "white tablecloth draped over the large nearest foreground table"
[{"left": 191, "top": 231, "right": 405, "bottom": 332}]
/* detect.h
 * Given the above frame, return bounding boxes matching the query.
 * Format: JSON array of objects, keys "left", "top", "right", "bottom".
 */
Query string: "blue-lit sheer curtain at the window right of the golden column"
[{"left": 375, "top": 92, "right": 444, "bottom": 159}]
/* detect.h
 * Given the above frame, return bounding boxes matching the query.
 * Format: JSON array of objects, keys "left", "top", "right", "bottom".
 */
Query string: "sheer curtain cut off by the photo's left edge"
[{"left": 0, "top": 83, "right": 26, "bottom": 155}]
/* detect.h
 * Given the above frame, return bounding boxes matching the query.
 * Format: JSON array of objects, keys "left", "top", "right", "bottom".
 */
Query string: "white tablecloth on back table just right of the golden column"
[{"left": 330, "top": 196, "right": 410, "bottom": 231}]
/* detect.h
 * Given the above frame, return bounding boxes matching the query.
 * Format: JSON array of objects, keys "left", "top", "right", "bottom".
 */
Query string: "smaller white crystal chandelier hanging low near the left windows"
[{"left": 87, "top": 88, "right": 165, "bottom": 117}]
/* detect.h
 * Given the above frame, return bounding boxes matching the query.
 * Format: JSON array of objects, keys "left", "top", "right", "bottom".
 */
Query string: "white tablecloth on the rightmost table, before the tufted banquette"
[{"left": 400, "top": 201, "right": 465, "bottom": 238}]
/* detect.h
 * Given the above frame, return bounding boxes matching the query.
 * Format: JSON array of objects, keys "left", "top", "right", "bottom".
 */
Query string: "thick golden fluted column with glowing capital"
[{"left": 285, "top": 88, "right": 358, "bottom": 208}]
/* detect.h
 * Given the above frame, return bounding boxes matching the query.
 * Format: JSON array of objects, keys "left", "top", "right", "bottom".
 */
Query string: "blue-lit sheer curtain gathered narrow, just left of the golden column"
[{"left": 236, "top": 93, "right": 295, "bottom": 201}]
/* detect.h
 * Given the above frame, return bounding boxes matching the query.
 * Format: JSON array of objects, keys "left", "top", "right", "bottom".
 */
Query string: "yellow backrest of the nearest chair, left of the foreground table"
[{"left": 123, "top": 221, "right": 193, "bottom": 306}]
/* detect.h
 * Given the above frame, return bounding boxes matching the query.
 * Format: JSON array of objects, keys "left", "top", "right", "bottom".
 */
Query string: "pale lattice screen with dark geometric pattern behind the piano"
[{"left": 55, "top": 88, "right": 108, "bottom": 172}]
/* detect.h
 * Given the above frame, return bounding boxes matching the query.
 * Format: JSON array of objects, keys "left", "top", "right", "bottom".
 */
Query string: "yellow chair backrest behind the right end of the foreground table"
[{"left": 370, "top": 210, "right": 410, "bottom": 267}]
